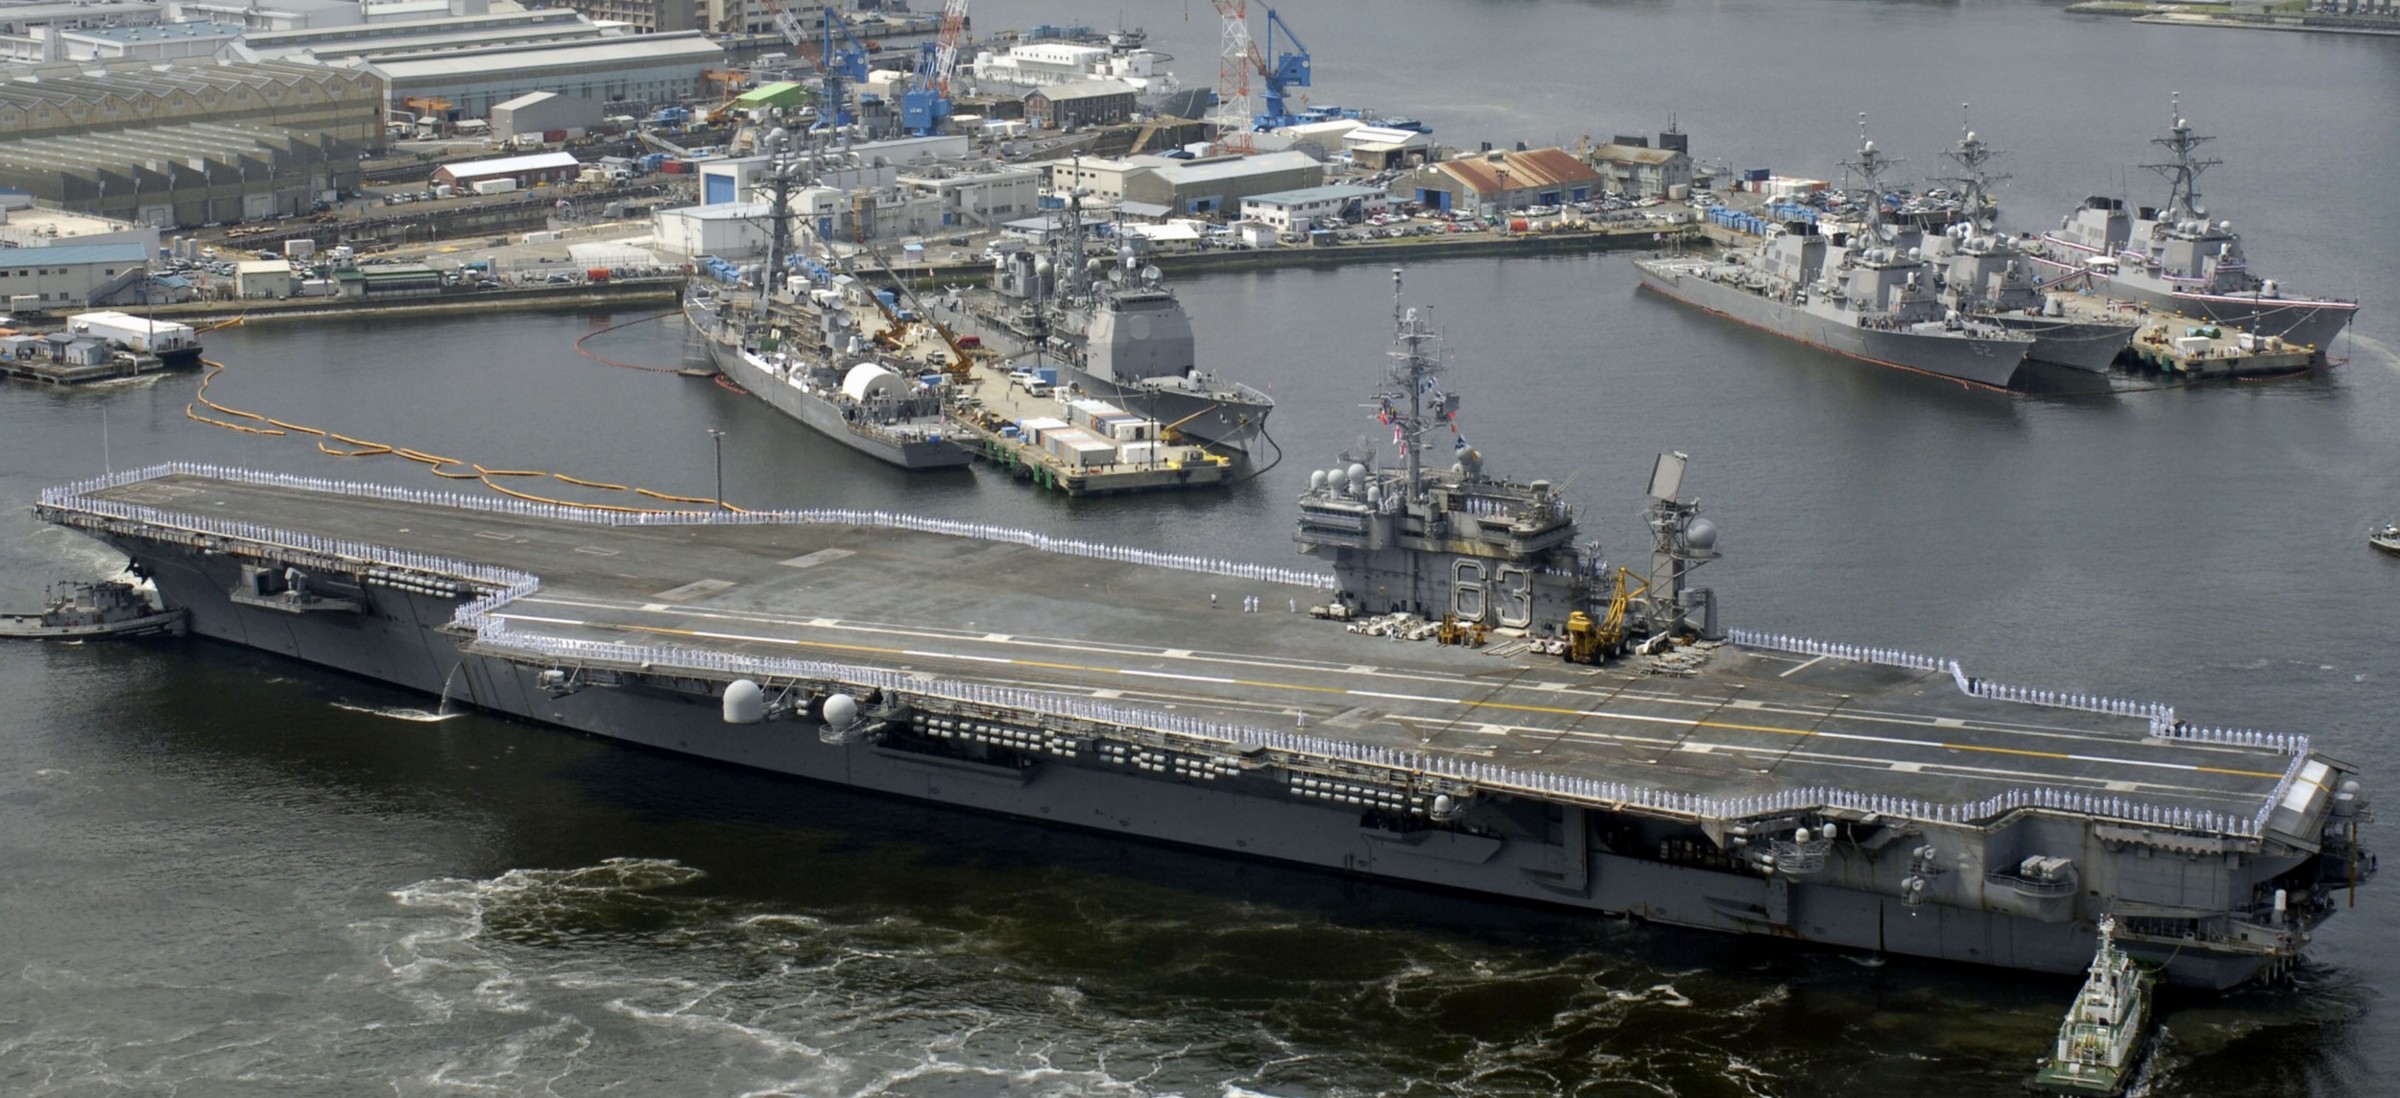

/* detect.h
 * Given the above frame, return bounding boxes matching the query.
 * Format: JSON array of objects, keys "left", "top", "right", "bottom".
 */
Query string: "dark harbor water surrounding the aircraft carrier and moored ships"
[{"left": 0, "top": 0, "right": 2400, "bottom": 1096}]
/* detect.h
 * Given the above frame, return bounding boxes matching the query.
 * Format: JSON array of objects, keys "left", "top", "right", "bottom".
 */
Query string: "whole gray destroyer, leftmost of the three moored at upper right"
[{"left": 1634, "top": 127, "right": 2033, "bottom": 388}]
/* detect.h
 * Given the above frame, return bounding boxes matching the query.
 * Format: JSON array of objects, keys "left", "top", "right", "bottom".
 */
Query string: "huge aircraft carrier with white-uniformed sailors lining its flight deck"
[{"left": 36, "top": 274, "right": 2376, "bottom": 988}]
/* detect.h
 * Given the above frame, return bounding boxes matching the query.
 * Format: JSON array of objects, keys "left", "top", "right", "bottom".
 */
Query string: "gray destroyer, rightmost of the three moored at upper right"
[{"left": 2035, "top": 105, "right": 2359, "bottom": 362}]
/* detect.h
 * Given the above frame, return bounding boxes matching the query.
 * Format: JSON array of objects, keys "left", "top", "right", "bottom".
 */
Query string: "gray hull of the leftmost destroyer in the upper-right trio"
[{"left": 1634, "top": 261, "right": 2026, "bottom": 388}]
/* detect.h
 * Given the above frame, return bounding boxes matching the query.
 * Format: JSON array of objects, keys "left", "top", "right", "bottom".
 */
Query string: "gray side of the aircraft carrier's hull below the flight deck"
[{"left": 103, "top": 542, "right": 2261, "bottom": 988}]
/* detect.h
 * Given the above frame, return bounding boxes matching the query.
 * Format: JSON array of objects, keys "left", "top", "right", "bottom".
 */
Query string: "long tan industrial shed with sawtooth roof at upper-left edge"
[{"left": 0, "top": 60, "right": 384, "bottom": 225}]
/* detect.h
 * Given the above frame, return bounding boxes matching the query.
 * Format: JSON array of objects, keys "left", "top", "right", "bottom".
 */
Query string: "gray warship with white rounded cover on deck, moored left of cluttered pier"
[{"left": 684, "top": 129, "right": 974, "bottom": 470}]
